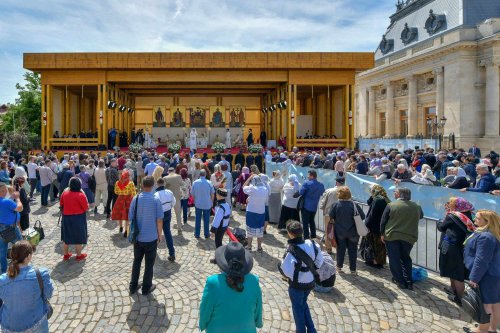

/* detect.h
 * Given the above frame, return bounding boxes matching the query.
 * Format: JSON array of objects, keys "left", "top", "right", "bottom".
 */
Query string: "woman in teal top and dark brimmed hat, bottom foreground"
[{"left": 199, "top": 242, "right": 262, "bottom": 333}]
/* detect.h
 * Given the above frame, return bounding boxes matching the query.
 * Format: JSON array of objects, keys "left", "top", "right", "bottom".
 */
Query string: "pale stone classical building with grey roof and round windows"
[{"left": 355, "top": 0, "right": 500, "bottom": 154}]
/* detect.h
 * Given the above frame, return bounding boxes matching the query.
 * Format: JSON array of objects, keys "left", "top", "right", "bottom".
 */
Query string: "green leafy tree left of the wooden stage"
[{"left": 0, "top": 72, "right": 42, "bottom": 137}]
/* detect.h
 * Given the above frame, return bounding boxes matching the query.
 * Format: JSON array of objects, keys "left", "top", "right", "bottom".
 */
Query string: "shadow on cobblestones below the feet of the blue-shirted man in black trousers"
[{"left": 127, "top": 292, "right": 170, "bottom": 332}]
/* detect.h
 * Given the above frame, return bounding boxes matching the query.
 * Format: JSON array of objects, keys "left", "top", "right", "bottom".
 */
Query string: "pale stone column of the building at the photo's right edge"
[{"left": 484, "top": 58, "right": 500, "bottom": 137}]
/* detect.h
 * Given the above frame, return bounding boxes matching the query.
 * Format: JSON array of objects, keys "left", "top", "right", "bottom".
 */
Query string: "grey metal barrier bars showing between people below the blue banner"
[{"left": 314, "top": 201, "right": 441, "bottom": 272}]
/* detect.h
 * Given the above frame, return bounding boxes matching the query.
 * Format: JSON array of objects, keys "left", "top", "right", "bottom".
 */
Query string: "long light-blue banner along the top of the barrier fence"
[{"left": 266, "top": 163, "right": 500, "bottom": 220}]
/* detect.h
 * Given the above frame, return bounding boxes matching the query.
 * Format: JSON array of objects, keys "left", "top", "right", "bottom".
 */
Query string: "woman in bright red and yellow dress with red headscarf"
[{"left": 111, "top": 171, "right": 136, "bottom": 238}]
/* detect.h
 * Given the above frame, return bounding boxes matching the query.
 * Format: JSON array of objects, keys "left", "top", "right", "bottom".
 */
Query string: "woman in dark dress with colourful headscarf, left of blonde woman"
[{"left": 437, "top": 197, "right": 476, "bottom": 305}]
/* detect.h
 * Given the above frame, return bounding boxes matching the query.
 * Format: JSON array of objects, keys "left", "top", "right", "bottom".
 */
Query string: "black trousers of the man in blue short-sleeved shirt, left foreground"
[{"left": 129, "top": 240, "right": 158, "bottom": 293}]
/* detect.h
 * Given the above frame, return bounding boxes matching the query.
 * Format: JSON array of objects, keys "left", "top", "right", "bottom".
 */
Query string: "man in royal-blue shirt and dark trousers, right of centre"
[{"left": 296, "top": 170, "right": 325, "bottom": 239}]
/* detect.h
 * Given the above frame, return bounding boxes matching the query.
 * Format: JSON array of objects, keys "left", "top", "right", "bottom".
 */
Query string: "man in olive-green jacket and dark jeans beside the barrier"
[{"left": 380, "top": 187, "right": 424, "bottom": 290}]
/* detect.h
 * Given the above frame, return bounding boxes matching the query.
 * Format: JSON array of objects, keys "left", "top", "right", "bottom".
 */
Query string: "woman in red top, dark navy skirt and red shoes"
[{"left": 59, "top": 177, "right": 89, "bottom": 261}]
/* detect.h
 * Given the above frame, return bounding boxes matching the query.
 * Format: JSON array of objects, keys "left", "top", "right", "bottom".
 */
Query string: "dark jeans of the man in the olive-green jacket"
[{"left": 385, "top": 240, "right": 413, "bottom": 286}]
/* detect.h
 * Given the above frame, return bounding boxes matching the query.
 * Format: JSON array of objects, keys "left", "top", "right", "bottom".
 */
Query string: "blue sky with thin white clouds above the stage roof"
[{"left": 0, "top": 0, "right": 396, "bottom": 104}]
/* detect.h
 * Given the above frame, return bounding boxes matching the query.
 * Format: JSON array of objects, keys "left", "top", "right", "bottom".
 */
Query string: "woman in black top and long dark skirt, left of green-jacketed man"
[{"left": 361, "top": 184, "right": 391, "bottom": 268}]
